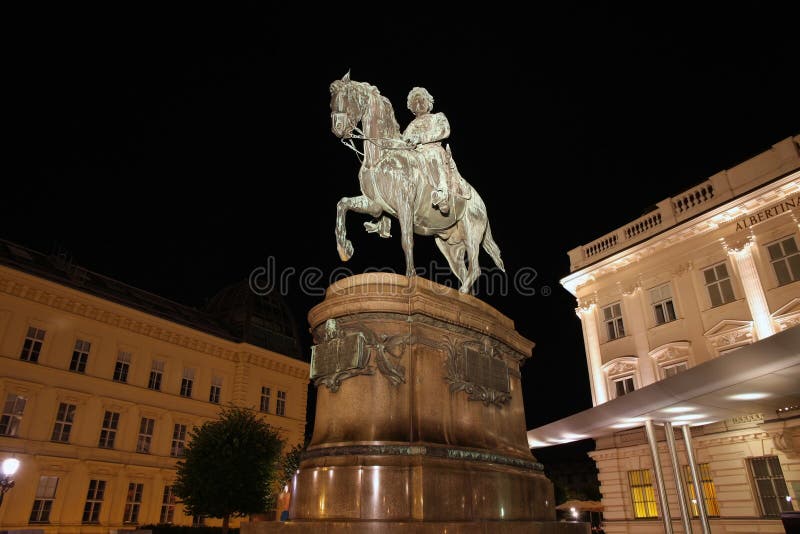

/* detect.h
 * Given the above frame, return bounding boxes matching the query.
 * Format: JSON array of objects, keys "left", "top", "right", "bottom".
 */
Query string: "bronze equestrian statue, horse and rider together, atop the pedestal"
[{"left": 330, "top": 72, "right": 505, "bottom": 293}]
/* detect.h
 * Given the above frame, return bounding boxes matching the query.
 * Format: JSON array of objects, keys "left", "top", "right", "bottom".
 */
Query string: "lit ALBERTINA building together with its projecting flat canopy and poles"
[{"left": 528, "top": 136, "right": 800, "bottom": 534}]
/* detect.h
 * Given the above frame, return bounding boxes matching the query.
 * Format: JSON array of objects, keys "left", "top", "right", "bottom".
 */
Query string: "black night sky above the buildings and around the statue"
[{"left": 7, "top": 2, "right": 800, "bottom": 436}]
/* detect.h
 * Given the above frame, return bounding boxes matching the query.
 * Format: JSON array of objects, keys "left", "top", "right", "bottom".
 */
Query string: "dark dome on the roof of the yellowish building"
[{"left": 205, "top": 279, "right": 303, "bottom": 360}]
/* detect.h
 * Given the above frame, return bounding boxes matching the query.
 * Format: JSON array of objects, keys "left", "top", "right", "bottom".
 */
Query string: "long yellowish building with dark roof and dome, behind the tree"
[{"left": 0, "top": 245, "right": 309, "bottom": 533}]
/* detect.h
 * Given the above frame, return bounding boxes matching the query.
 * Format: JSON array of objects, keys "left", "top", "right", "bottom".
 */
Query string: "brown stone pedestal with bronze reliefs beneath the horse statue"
[{"left": 241, "top": 273, "right": 589, "bottom": 534}]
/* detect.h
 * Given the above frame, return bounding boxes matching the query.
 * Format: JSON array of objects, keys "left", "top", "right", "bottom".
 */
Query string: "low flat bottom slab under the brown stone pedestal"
[{"left": 239, "top": 521, "right": 591, "bottom": 534}]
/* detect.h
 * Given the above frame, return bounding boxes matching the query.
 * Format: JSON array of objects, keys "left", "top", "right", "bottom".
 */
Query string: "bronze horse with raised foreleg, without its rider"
[{"left": 330, "top": 72, "right": 505, "bottom": 293}]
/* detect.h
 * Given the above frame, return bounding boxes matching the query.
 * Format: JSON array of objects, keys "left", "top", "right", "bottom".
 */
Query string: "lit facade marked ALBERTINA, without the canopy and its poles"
[{"left": 561, "top": 136, "right": 800, "bottom": 534}]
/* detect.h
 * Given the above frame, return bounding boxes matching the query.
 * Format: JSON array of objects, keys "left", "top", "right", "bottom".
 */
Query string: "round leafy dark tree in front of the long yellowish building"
[{"left": 174, "top": 406, "right": 283, "bottom": 534}]
